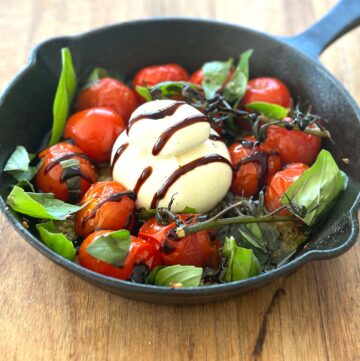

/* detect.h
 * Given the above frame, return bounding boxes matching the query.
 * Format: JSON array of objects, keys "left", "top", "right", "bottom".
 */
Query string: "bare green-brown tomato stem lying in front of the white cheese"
[{"left": 176, "top": 215, "right": 296, "bottom": 238}]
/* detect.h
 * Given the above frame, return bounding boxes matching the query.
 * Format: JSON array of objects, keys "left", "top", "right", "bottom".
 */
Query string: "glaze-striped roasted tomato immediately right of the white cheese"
[{"left": 229, "top": 137, "right": 281, "bottom": 197}]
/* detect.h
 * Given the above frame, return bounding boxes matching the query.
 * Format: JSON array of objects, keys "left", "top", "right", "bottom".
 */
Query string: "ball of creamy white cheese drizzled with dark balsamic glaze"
[{"left": 111, "top": 100, "right": 232, "bottom": 213}]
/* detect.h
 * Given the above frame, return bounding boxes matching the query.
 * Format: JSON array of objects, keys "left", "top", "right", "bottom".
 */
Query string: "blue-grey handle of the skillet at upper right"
[{"left": 282, "top": 0, "right": 360, "bottom": 59}]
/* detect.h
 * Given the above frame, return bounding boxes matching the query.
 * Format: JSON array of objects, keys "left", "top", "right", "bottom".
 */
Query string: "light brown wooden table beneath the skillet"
[{"left": 0, "top": 0, "right": 360, "bottom": 361}]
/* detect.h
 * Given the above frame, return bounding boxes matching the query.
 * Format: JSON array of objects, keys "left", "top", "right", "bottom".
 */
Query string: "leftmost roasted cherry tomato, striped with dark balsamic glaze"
[{"left": 35, "top": 142, "right": 97, "bottom": 202}]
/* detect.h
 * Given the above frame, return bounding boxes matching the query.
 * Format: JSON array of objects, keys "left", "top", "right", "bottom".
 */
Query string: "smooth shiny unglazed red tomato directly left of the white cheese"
[{"left": 64, "top": 108, "right": 125, "bottom": 162}]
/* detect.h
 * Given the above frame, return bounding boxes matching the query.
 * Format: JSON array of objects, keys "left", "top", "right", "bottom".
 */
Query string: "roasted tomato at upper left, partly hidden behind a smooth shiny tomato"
[{"left": 75, "top": 78, "right": 138, "bottom": 122}]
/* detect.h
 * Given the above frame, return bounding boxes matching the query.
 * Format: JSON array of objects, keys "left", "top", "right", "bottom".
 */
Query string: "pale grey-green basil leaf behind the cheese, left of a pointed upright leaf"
[{"left": 201, "top": 59, "right": 233, "bottom": 99}]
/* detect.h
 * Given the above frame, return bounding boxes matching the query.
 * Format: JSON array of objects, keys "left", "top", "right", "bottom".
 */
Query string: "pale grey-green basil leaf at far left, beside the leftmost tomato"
[{"left": 4, "top": 145, "right": 42, "bottom": 181}]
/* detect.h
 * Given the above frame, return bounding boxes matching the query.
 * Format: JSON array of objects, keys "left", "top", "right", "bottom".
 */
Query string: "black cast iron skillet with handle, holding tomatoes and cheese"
[{"left": 0, "top": 0, "right": 360, "bottom": 304}]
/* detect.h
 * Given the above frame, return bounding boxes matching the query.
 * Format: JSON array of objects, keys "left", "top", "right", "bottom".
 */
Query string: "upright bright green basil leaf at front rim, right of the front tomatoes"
[{"left": 222, "top": 237, "right": 261, "bottom": 282}]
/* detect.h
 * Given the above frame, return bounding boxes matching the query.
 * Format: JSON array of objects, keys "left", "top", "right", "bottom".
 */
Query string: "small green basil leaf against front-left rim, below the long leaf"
[{"left": 36, "top": 221, "right": 76, "bottom": 261}]
